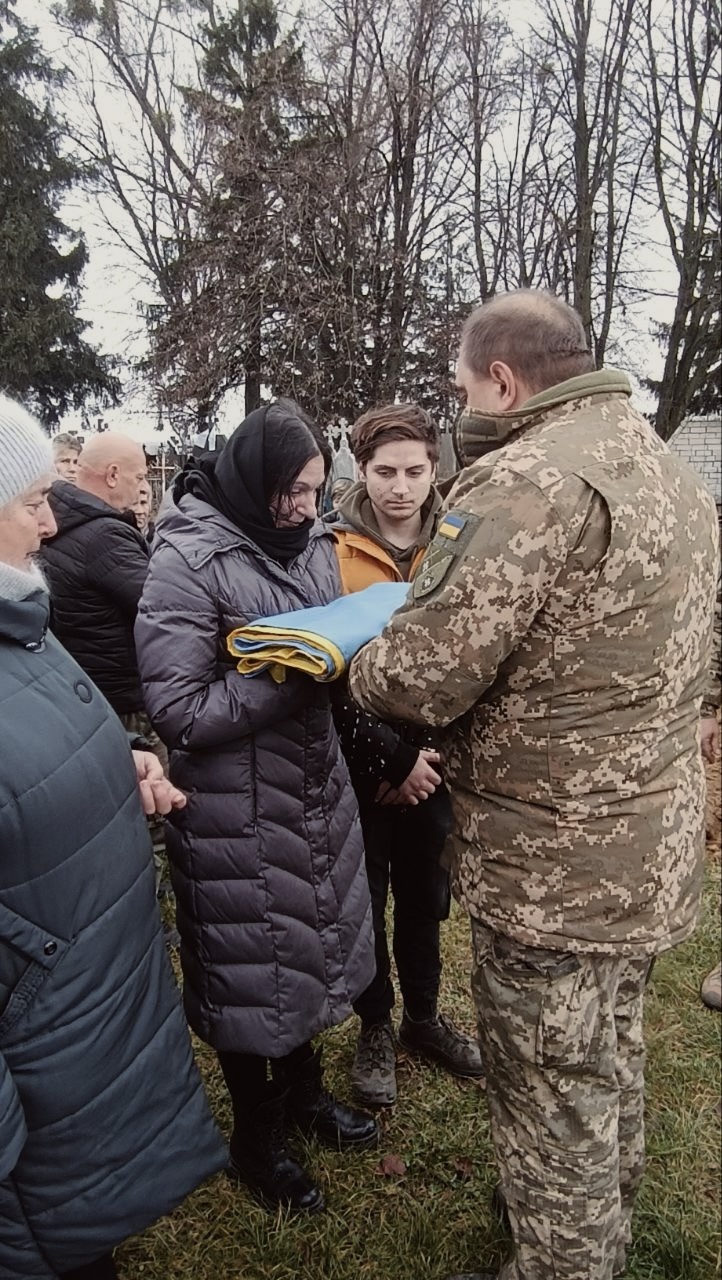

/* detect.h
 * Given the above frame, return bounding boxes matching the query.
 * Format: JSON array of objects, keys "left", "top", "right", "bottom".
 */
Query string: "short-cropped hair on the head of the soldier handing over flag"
[{"left": 461, "top": 289, "right": 594, "bottom": 392}]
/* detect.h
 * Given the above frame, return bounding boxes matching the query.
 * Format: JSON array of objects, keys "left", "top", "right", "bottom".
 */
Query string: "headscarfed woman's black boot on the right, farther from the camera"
[{"left": 285, "top": 1050, "right": 379, "bottom": 1151}]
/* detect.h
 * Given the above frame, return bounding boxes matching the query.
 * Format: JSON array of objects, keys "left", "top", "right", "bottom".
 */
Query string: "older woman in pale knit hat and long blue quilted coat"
[{"left": 0, "top": 396, "right": 227, "bottom": 1280}]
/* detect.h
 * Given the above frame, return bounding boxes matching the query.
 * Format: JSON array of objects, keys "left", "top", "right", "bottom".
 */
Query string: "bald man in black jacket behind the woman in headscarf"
[{"left": 42, "top": 431, "right": 148, "bottom": 716}]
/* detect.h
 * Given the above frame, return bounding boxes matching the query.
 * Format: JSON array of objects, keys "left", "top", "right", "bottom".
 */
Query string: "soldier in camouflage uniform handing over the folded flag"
[{"left": 349, "top": 291, "right": 717, "bottom": 1280}]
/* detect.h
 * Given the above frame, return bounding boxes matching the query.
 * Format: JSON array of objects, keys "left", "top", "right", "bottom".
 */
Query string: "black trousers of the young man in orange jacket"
[{"left": 353, "top": 785, "right": 452, "bottom": 1023}]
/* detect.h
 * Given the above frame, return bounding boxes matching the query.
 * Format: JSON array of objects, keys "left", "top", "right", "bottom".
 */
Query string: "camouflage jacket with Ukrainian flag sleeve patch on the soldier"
[{"left": 351, "top": 370, "right": 717, "bottom": 955}]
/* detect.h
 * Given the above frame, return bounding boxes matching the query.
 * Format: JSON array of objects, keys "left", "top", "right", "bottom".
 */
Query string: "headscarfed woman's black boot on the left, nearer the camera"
[{"left": 228, "top": 1093, "right": 325, "bottom": 1213}]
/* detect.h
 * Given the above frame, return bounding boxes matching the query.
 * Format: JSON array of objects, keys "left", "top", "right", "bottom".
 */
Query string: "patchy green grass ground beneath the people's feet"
[{"left": 118, "top": 768, "right": 722, "bottom": 1280}]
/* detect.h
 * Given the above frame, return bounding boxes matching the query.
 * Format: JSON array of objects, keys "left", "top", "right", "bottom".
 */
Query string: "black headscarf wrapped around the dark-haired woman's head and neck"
[{"left": 174, "top": 404, "right": 319, "bottom": 563}]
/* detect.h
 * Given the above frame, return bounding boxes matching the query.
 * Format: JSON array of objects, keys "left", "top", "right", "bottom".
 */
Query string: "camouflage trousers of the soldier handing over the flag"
[{"left": 471, "top": 920, "right": 650, "bottom": 1280}]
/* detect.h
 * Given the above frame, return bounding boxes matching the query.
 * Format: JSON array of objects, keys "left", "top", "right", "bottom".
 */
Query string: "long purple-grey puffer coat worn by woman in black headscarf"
[{"left": 136, "top": 494, "right": 374, "bottom": 1057}]
